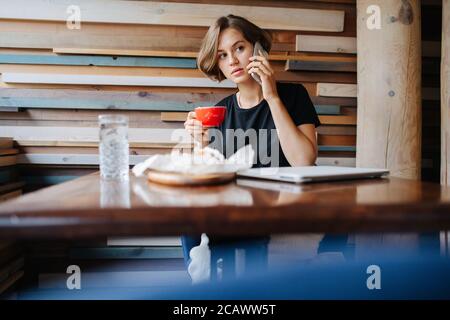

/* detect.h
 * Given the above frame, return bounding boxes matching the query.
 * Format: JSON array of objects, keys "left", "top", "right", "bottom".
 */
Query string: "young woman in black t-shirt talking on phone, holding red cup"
[{"left": 182, "top": 15, "right": 320, "bottom": 262}]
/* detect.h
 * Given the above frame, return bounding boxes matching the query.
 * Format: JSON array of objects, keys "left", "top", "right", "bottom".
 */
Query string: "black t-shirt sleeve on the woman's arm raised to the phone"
[{"left": 286, "top": 84, "right": 320, "bottom": 127}]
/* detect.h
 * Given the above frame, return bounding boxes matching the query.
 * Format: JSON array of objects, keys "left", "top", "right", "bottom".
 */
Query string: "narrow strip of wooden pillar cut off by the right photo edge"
[{"left": 441, "top": 0, "right": 450, "bottom": 185}]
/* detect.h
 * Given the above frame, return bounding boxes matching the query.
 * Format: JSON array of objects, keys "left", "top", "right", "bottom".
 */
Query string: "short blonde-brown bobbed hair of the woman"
[{"left": 197, "top": 14, "right": 272, "bottom": 82}]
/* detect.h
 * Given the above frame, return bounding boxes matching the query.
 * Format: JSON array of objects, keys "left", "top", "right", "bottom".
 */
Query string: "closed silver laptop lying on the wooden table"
[{"left": 237, "top": 166, "right": 389, "bottom": 183}]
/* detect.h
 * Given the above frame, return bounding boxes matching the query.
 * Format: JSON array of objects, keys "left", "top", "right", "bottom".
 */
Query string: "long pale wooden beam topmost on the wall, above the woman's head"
[{"left": 0, "top": 0, "right": 345, "bottom": 32}]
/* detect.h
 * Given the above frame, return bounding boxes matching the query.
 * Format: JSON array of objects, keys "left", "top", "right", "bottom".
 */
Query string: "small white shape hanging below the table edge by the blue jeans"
[{"left": 188, "top": 233, "right": 211, "bottom": 284}]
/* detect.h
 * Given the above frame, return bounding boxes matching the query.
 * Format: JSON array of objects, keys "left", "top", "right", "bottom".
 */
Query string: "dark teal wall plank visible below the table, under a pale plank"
[{"left": 69, "top": 246, "right": 183, "bottom": 259}]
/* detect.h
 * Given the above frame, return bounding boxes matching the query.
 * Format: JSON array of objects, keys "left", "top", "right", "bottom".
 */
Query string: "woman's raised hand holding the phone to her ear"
[{"left": 247, "top": 52, "right": 278, "bottom": 101}]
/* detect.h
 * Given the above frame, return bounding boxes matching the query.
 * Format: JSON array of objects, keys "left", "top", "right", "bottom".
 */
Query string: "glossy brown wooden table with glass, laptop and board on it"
[{"left": 0, "top": 173, "right": 450, "bottom": 239}]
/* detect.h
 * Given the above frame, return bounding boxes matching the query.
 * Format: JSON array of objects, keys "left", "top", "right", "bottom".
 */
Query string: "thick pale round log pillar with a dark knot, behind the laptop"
[{"left": 356, "top": 0, "right": 422, "bottom": 179}]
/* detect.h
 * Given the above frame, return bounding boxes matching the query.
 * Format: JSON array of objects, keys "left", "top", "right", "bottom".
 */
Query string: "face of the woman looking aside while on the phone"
[{"left": 217, "top": 28, "right": 253, "bottom": 84}]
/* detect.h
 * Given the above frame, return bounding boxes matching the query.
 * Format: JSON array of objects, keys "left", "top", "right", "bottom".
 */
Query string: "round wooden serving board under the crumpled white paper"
[{"left": 147, "top": 170, "right": 236, "bottom": 186}]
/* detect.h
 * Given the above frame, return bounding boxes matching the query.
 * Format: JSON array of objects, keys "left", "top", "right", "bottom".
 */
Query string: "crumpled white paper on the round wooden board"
[{"left": 132, "top": 144, "right": 255, "bottom": 177}]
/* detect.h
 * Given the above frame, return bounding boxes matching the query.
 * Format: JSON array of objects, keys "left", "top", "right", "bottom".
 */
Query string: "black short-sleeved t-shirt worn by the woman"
[{"left": 210, "top": 83, "right": 320, "bottom": 168}]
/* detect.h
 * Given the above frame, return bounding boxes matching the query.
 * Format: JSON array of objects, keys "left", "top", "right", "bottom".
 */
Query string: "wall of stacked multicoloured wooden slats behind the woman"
[{"left": 0, "top": 0, "right": 356, "bottom": 186}]
